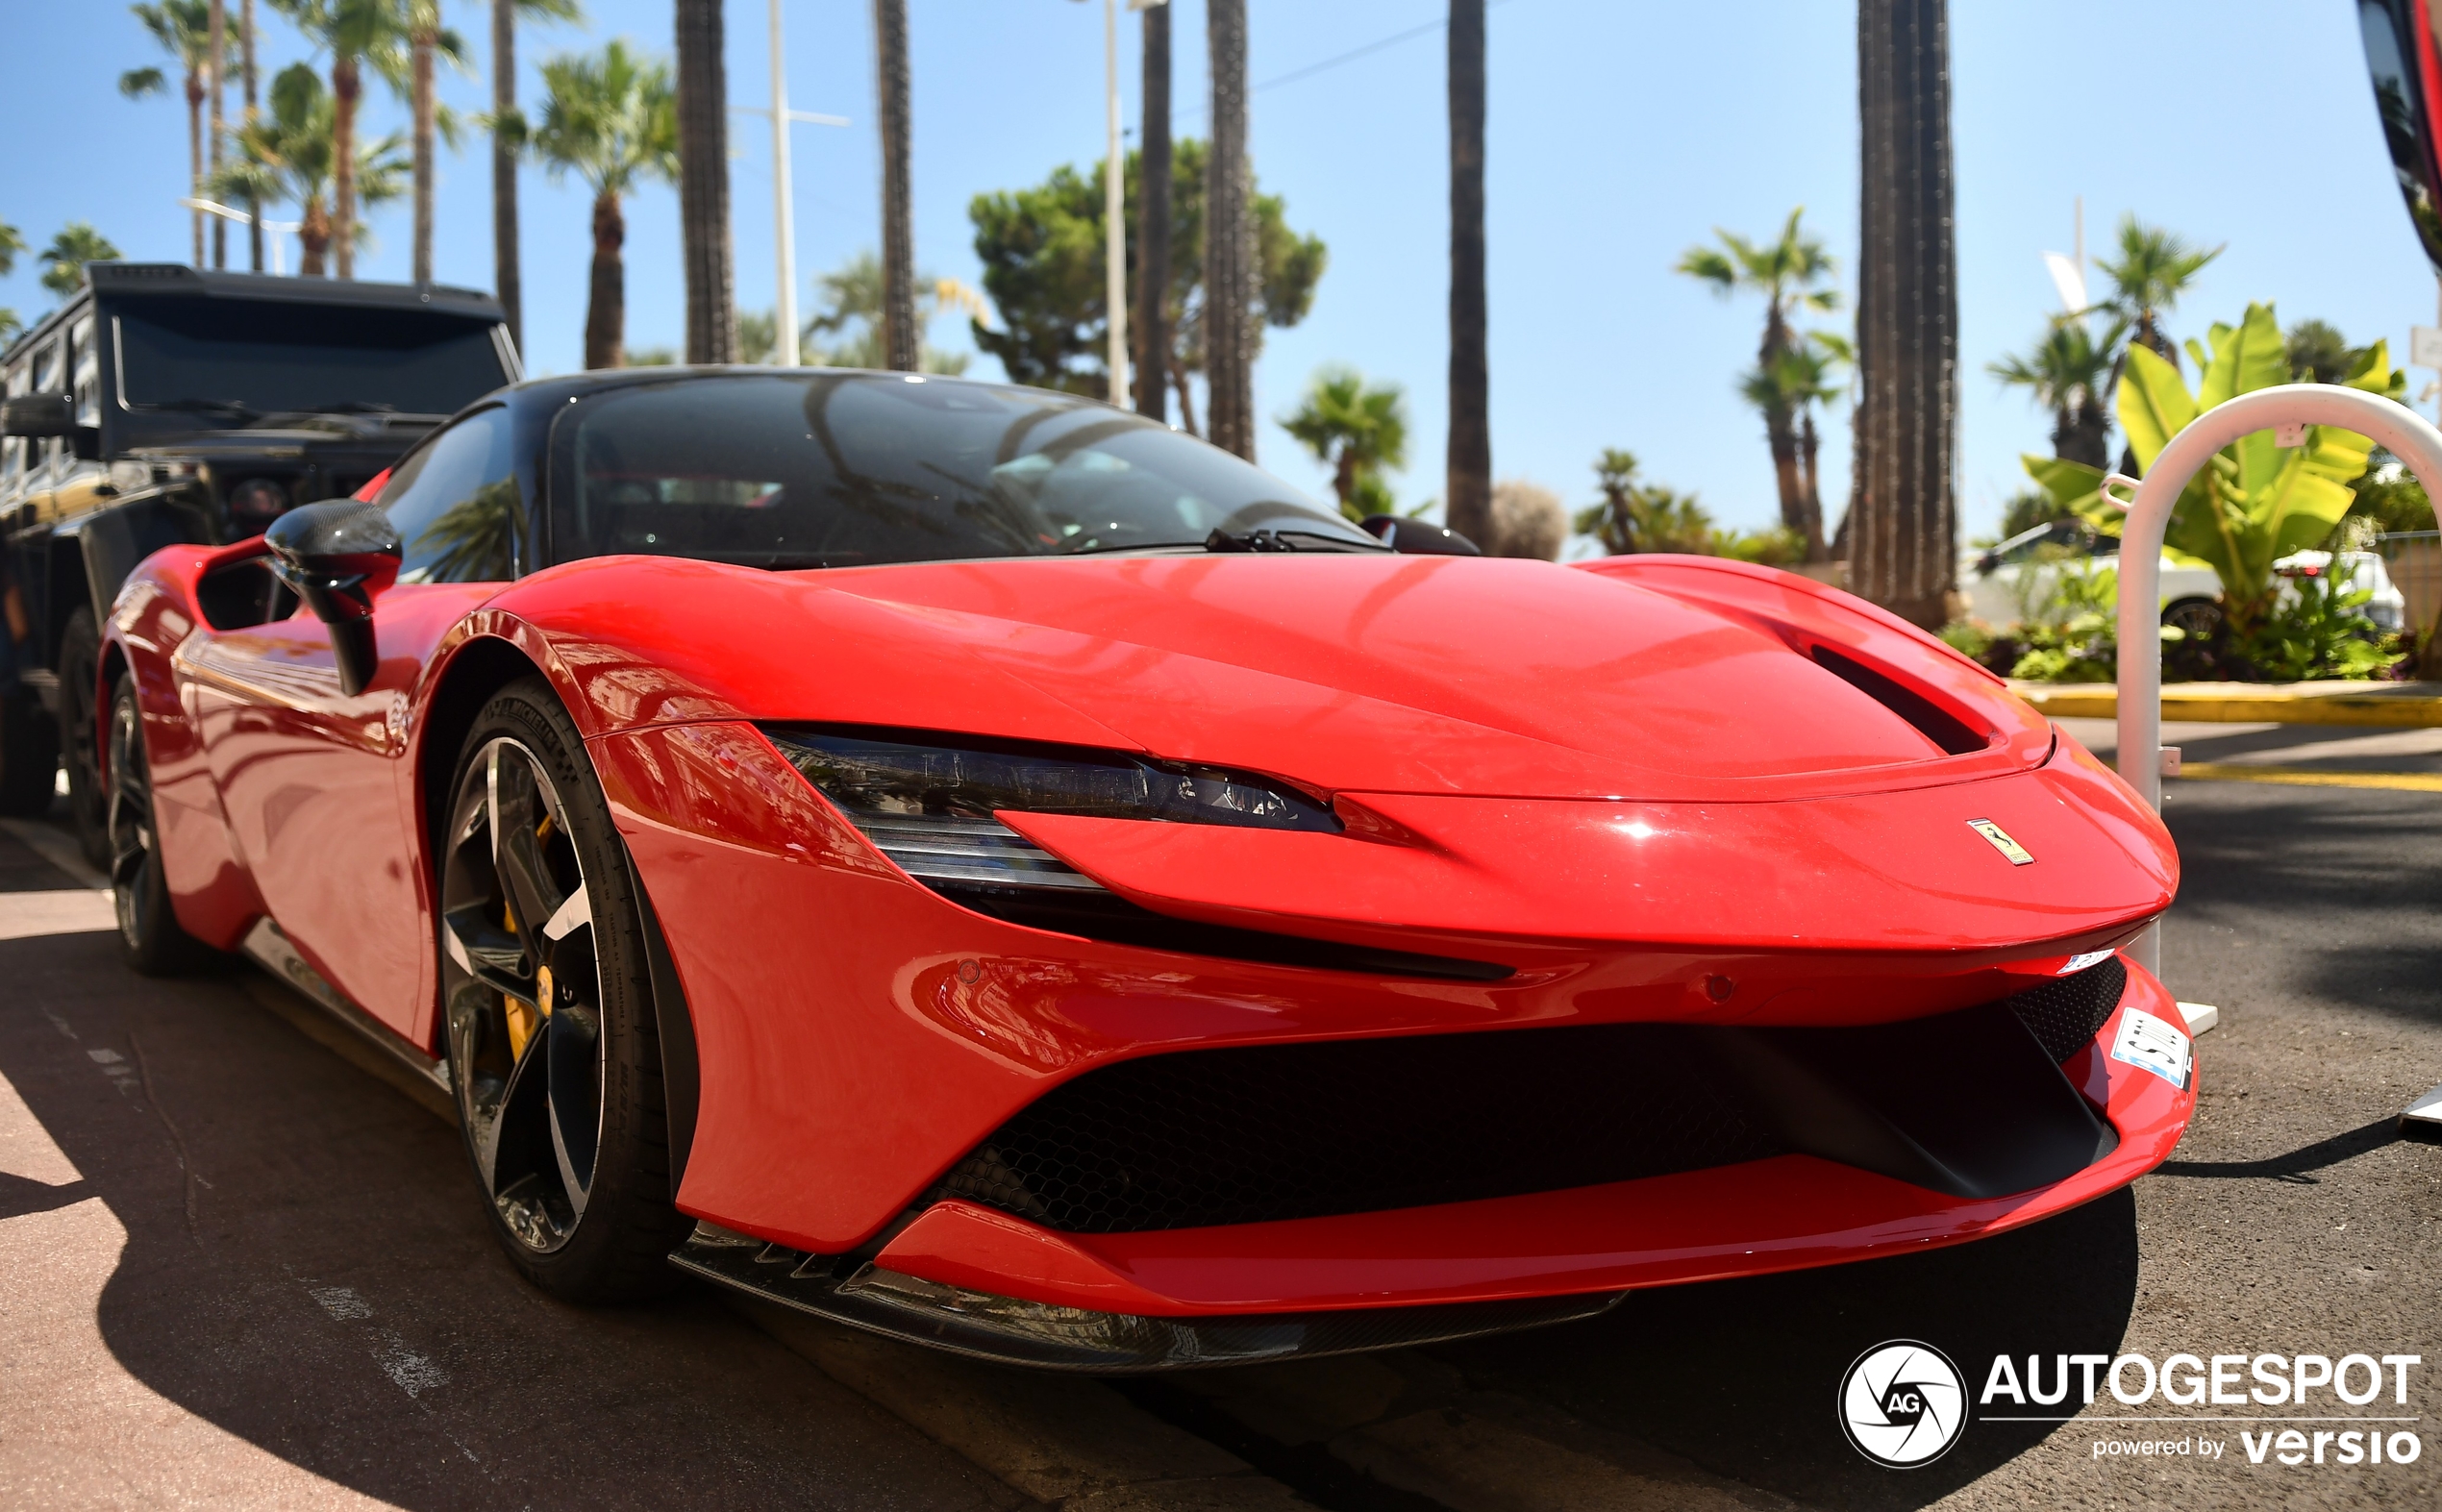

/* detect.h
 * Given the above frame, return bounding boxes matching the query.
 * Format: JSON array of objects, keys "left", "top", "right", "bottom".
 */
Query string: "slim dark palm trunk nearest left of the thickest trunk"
[{"left": 1443, "top": 0, "right": 1492, "bottom": 550}]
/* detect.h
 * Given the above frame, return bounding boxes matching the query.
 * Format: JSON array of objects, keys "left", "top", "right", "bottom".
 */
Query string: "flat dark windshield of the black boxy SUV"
[{"left": 110, "top": 298, "right": 508, "bottom": 420}]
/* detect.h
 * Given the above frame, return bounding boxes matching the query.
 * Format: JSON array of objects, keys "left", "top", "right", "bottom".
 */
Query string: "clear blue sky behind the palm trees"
[{"left": 0, "top": 0, "right": 2434, "bottom": 544}]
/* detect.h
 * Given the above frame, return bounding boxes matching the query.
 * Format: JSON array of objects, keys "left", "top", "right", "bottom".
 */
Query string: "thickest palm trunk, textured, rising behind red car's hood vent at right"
[{"left": 1849, "top": 0, "right": 1958, "bottom": 628}]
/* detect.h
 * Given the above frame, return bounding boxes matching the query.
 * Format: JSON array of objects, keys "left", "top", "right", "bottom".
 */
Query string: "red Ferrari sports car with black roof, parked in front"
[{"left": 98, "top": 369, "right": 2195, "bottom": 1371}]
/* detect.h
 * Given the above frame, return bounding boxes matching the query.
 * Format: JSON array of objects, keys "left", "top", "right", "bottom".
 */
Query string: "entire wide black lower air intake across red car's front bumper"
[{"left": 935, "top": 960, "right": 2127, "bottom": 1233}]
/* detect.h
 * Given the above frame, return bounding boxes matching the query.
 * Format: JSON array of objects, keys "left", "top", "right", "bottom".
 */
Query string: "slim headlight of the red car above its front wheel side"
[{"left": 764, "top": 726, "right": 1340, "bottom": 892}]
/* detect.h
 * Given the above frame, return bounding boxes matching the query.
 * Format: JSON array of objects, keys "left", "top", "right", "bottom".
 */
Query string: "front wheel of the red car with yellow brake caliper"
[{"left": 439, "top": 679, "right": 688, "bottom": 1301}]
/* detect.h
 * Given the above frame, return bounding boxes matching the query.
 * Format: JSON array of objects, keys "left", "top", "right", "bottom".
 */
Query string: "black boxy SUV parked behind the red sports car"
[{"left": 0, "top": 261, "right": 520, "bottom": 865}]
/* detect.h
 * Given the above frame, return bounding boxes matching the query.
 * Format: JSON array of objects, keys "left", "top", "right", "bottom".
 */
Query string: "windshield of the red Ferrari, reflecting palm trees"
[{"left": 552, "top": 371, "right": 1383, "bottom": 567}]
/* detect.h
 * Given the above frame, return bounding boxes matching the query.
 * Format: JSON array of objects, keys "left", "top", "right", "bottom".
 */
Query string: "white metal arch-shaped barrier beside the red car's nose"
[{"left": 2103, "top": 384, "right": 2442, "bottom": 1109}]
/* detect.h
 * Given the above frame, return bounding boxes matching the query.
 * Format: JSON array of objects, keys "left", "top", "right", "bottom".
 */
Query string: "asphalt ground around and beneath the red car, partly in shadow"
[{"left": 0, "top": 731, "right": 2442, "bottom": 1512}]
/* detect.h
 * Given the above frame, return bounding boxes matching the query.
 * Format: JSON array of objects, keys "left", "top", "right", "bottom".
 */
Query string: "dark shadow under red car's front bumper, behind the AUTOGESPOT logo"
[{"left": 1433, "top": 1190, "right": 2137, "bottom": 1509}]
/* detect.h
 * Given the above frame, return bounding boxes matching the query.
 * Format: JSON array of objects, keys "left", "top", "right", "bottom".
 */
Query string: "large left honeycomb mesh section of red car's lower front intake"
[{"left": 942, "top": 1024, "right": 1782, "bottom": 1233}]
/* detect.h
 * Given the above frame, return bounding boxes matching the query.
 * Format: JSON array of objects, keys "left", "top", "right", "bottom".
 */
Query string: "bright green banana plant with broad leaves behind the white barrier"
[{"left": 2025, "top": 306, "right": 2407, "bottom": 635}]
